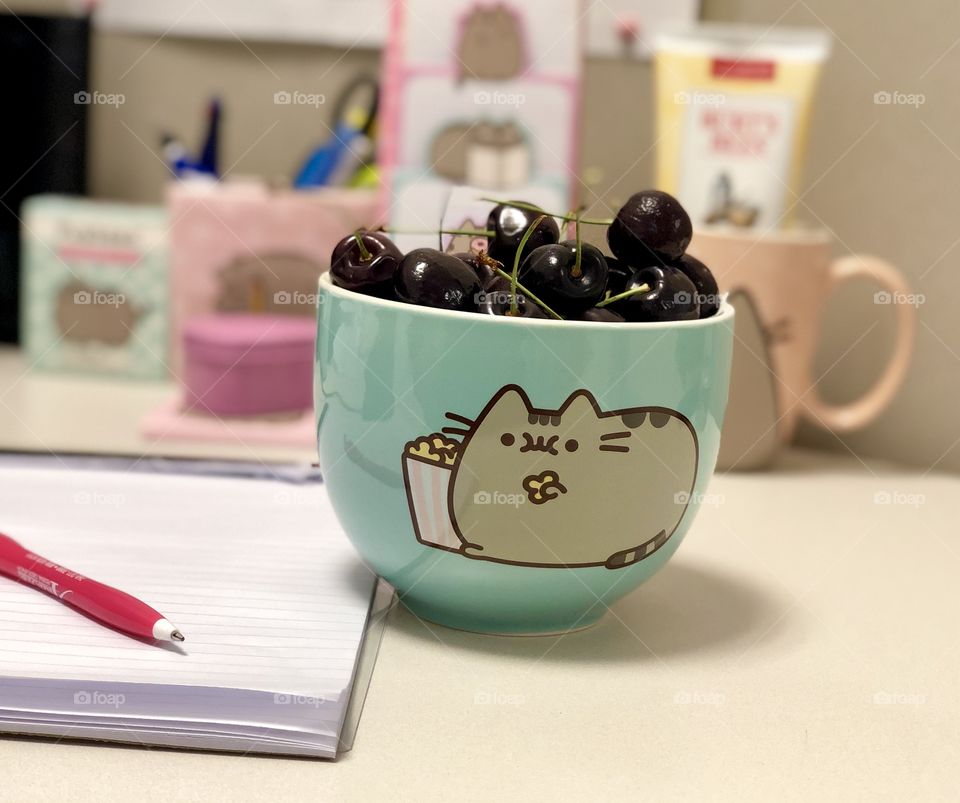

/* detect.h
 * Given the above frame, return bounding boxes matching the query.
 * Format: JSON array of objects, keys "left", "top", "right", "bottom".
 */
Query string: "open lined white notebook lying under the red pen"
[{"left": 0, "top": 460, "right": 376, "bottom": 757}]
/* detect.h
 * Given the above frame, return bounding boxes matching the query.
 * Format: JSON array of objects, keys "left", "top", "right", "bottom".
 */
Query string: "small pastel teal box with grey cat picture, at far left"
[{"left": 20, "top": 195, "right": 169, "bottom": 379}]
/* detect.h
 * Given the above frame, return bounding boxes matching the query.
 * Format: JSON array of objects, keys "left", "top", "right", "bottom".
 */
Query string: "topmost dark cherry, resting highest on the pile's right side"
[{"left": 607, "top": 190, "right": 693, "bottom": 265}]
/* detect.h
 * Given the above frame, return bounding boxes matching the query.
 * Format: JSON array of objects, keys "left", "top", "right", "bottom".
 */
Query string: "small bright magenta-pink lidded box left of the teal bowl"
[{"left": 183, "top": 314, "right": 316, "bottom": 416}]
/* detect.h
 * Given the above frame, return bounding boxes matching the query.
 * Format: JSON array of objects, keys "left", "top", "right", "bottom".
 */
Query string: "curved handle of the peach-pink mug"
[{"left": 802, "top": 254, "right": 917, "bottom": 432}]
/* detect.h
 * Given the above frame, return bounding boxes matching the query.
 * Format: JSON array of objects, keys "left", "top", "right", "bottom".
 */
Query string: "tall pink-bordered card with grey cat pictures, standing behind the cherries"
[{"left": 380, "top": 0, "right": 581, "bottom": 249}]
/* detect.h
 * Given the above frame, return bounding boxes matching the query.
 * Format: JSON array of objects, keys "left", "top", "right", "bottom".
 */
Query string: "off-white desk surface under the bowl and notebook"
[{"left": 0, "top": 352, "right": 960, "bottom": 803}]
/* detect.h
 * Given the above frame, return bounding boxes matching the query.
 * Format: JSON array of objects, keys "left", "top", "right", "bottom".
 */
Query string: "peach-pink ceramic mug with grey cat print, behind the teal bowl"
[{"left": 689, "top": 228, "right": 916, "bottom": 468}]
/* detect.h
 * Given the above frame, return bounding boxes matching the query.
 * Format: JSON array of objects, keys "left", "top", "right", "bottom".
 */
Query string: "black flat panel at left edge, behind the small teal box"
[{"left": 0, "top": 14, "right": 90, "bottom": 342}]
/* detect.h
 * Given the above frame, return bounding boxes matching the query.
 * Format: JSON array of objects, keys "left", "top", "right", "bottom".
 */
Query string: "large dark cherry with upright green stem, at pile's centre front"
[{"left": 519, "top": 240, "right": 607, "bottom": 317}]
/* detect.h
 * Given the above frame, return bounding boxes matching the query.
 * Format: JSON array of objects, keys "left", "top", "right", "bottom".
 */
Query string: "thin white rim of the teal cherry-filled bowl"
[{"left": 317, "top": 271, "right": 735, "bottom": 332}]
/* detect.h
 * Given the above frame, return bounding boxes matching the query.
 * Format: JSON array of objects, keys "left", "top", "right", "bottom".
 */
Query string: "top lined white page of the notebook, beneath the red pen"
[{"left": 0, "top": 468, "right": 375, "bottom": 714}]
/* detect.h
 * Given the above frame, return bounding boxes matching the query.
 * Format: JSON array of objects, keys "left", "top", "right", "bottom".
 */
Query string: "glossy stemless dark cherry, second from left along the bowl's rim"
[{"left": 393, "top": 248, "right": 480, "bottom": 312}]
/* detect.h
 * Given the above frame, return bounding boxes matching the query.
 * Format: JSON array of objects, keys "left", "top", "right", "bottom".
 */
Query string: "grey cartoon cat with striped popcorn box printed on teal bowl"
[{"left": 402, "top": 385, "right": 699, "bottom": 569}]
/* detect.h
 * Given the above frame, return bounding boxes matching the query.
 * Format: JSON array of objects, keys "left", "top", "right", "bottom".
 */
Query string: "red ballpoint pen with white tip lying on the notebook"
[{"left": 0, "top": 533, "right": 184, "bottom": 641}]
